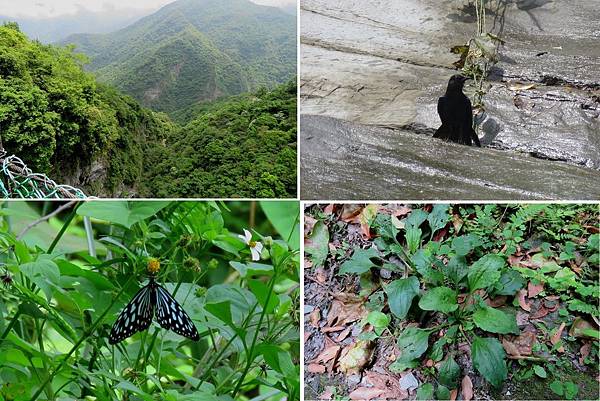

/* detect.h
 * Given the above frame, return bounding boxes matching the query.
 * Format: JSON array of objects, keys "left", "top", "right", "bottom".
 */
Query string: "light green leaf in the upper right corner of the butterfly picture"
[{"left": 260, "top": 201, "right": 300, "bottom": 251}]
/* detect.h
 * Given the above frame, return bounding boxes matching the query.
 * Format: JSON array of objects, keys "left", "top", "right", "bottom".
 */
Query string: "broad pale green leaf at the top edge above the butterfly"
[{"left": 77, "top": 200, "right": 170, "bottom": 228}]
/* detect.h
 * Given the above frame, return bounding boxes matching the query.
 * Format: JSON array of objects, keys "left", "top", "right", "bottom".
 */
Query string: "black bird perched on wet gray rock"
[{"left": 433, "top": 74, "right": 481, "bottom": 147}]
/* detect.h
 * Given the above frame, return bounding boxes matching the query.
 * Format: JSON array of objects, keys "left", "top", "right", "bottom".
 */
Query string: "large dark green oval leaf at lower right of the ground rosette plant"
[{"left": 471, "top": 336, "right": 508, "bottom": 387}]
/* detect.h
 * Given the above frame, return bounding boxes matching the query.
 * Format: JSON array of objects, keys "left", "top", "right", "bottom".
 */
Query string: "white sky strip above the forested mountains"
[{"left": 0, "top": 0, "right": 296, "bottom": 18}]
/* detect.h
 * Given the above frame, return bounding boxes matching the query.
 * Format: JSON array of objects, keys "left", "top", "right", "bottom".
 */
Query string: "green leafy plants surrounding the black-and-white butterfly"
[{"left": 0, "top": 201, "right": 300, "bottom": 400}]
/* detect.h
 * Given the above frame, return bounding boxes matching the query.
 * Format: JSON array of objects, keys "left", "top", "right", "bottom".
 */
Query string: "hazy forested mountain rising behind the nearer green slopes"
[{"left": 62, "top": 0, "right": 296, "bottom": 113}]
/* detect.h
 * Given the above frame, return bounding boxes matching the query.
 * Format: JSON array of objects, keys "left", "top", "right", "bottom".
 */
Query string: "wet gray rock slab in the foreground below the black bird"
[{"left": 300, "top": 116, "right": 600, "bottom": 200}]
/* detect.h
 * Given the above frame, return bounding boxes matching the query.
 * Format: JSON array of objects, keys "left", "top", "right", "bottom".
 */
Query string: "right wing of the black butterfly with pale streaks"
[{"left": 156, "top": 284, "right": 200, "bottom": 341}]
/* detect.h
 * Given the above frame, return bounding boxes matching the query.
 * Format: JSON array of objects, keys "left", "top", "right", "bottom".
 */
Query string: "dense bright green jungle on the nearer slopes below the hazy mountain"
[{"left": 0, "top": 23, "right": 296, "bottom": 197}]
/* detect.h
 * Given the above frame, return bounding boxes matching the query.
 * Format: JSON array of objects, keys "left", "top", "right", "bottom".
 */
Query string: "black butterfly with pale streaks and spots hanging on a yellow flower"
[{"left": 108, "top": 276, "right": 200, "bottom": 344}]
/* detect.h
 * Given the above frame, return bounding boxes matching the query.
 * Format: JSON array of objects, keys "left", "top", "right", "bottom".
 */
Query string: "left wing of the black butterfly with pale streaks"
[{"left": 108, "top": 282, "right": 154, "bottom": 344}]
